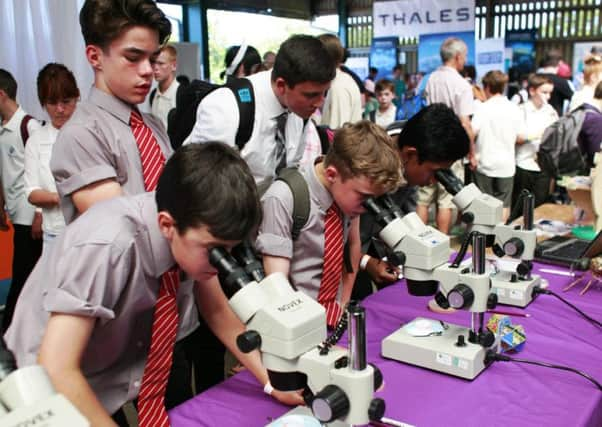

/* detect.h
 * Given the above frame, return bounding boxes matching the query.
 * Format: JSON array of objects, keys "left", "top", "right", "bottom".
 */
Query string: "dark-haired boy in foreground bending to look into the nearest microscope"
[{"left": 6, "top": 143, "right": 286, "bottom": 427}]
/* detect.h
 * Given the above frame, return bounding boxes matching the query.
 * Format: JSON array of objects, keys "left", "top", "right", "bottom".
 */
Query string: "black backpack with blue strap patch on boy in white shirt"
[{"left": 167, "top": 78, "right": 255, "bottom": 150}]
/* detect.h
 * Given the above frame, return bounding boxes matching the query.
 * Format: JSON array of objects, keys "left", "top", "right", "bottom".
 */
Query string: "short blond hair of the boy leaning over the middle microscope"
[{"left": 324, "top": 120, "right": 401, "bottom": 192}]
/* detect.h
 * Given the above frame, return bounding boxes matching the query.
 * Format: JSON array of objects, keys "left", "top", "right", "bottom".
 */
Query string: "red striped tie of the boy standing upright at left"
[{"left": 130, "top": 110, "right": 165, "bottom": 191}]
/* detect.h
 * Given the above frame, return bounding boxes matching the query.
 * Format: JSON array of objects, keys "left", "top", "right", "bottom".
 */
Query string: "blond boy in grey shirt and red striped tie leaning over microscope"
[{"left": 257, "top": 120, "right": 400, "bottom": 327}]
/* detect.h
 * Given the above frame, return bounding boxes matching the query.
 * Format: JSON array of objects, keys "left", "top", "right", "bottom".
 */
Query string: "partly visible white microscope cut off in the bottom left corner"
[{"left": 0, "top": 337, "right": 90, "bottom": 427}]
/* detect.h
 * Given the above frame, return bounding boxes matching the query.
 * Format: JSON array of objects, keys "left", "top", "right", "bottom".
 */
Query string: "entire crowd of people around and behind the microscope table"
[{"left": 0, "top": 0, "right": 602, "bottom": 427}]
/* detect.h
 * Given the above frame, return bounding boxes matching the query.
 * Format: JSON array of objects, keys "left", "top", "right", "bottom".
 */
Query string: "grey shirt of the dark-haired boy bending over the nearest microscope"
[{"left": 4, "top": 193, "right": 197, "bottom": 413}]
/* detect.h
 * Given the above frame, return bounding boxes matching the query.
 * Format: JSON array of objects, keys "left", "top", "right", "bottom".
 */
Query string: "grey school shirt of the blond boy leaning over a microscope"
[{"left": 256, "top": 159, "right": 350, "bottom": 303}]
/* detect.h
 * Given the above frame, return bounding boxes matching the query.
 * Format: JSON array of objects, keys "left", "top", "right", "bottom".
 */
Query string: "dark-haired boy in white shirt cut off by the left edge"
[{"left": 0, "top": 69, "right": 42, "bottom": 331}]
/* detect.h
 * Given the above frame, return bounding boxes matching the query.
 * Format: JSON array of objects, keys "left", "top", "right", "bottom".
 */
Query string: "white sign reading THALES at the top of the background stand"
[{"left": 372, "top": 0, "right": 475, "bottom": 37}]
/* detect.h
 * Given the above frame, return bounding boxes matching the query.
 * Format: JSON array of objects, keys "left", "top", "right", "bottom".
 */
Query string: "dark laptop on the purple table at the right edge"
[{"left": 535, "top": 231, "right": 602, "bottom": 270}]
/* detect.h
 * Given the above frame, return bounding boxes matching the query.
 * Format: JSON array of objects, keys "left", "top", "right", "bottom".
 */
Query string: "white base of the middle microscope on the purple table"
[{"left": 381, "top": 317, "right": 486, "bottom": 380}]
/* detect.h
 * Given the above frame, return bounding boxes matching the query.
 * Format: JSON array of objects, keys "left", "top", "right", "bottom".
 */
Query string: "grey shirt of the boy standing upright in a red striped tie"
[{"left": 50, "top": 87, "right": 173, "bottom": 224}]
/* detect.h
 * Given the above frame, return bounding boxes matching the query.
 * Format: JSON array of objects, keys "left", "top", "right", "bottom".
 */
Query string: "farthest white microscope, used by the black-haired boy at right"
[{"left": 435, "top": 169, "right": 541, "bottom": 307}]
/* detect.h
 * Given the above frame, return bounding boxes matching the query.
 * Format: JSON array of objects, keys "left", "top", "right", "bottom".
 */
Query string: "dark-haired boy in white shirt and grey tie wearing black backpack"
[{"left": 184, "top": 35, "right": 335, "bottom": 188}]
